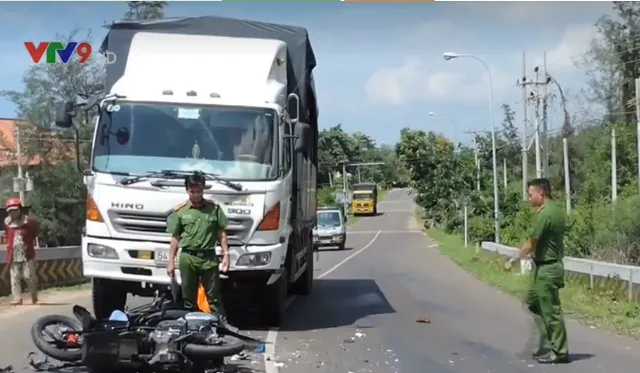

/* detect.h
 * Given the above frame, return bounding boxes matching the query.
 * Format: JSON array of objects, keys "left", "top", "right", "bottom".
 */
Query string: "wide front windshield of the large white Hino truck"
[{"left": 93, "top": 101, "right": 278, "bottom": 180}]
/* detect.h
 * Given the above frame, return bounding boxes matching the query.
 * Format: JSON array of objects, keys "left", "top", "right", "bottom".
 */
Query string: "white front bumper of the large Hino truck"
[{"left": 82, "top": 237, "right": 287, "bottom": 284}]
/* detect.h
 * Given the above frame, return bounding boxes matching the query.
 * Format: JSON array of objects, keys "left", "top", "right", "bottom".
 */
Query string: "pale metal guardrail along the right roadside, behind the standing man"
[{"left": 480, "top": 241, "right": 640, "bottom": 299}]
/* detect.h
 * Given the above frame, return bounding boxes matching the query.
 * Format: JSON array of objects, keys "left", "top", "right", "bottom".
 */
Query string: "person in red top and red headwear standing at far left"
[{"left": 4, "top": 198, "right": 38, "bottom": 305}]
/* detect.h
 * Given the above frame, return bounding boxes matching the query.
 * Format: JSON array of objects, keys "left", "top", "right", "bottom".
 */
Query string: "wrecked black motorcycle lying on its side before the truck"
[{"left": 31, "top": 295, "right": 261, "bottom": 373}]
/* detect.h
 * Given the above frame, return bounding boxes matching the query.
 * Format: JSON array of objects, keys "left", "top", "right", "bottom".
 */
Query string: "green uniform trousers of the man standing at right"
[{"left": 527, "top": 262, "right": 569, "bottom": 356}]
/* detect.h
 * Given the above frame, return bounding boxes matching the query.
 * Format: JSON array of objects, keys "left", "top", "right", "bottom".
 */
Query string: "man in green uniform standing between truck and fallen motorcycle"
[{"left": 167, "top": 173, "right": 229, "bottom": 318}]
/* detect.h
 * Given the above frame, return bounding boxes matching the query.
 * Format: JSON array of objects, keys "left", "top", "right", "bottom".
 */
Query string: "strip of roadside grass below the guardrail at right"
[{"left": 421, "top": 208, "right": 640, "bottom": 339}]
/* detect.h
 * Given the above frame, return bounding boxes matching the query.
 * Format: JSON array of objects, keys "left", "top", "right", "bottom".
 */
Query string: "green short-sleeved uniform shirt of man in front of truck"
[{"left": 167, "top": 200, "right": 229, "bottom": 250}]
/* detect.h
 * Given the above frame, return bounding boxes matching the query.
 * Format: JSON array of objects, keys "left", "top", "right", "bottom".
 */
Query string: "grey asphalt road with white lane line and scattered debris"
[{"left": 0, "top": 190, "right": 640, "bottom": 373}]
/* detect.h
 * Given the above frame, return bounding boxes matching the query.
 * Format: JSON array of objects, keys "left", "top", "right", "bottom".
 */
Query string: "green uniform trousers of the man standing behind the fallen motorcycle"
[{"left": 179, "top": 250, "right": 226, "bottom": 317}]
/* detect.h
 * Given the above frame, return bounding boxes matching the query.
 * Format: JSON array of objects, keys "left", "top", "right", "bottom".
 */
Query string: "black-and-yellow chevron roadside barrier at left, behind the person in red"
[{"left": 0, "top": 246, "right": 86, "bottom": 296}]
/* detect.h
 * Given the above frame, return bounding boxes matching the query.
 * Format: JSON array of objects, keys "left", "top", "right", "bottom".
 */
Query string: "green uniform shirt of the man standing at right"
[{"left": 530, "top": 200, "right": 565, "bottom": 263}]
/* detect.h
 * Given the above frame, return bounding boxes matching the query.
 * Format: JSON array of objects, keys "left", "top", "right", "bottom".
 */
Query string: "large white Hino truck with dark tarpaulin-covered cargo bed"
[{"left": 56, "top": 17, "right": 318, "bottom": 325}]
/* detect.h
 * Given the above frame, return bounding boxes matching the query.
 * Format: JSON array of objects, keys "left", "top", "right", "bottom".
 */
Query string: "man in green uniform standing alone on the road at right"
[{"left": 505, "top": 179, "right": 569, "bottom": 364}]
